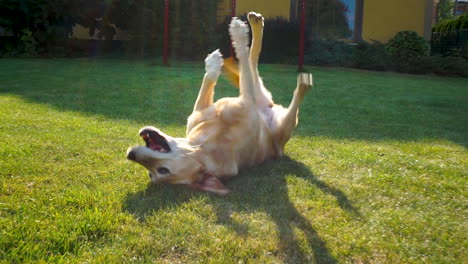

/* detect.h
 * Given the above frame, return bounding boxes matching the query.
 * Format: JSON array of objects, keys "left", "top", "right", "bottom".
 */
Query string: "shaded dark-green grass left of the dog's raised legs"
[{"left": 0, "top": 58, "right": 208, "bottom": 126}]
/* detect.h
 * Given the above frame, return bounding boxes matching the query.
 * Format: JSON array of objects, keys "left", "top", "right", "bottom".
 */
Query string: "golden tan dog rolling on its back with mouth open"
[{"left": 127, "top": 12, "right": 312, "bottom": 194}]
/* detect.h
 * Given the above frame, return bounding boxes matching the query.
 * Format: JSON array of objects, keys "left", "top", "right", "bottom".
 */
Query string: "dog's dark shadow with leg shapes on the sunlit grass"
[{"left": 124, "top": 157, "right": 361, "bottom": 263}]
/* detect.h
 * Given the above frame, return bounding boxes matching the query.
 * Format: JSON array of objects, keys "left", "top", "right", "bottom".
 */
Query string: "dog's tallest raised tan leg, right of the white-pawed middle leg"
[{"left": 247, "top": 12, "right": 273, "bottom": 107}]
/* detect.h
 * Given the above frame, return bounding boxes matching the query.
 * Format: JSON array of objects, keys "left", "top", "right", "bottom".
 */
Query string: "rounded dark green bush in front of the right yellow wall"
[{"left": 385, "top": 31, "right": 429, "bottom": 63}]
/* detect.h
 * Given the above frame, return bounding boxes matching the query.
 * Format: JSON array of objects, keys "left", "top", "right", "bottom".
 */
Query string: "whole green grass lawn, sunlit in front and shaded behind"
[{"left": 0, "top": 59, "right": 468, "bottom": 263}]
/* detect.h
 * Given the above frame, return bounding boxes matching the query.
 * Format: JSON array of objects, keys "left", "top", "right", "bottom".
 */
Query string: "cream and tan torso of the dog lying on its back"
[{"left": 187, "top": 98, "right": 275, "bottom": 176}]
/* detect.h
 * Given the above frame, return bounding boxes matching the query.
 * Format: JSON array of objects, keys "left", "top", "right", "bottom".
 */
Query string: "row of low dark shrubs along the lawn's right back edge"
[{"left": 305, "top": 32, "right": 468, "bottom": 77}]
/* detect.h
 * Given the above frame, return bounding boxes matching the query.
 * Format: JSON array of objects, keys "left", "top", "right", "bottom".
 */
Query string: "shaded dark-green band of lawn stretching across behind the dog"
[{"left": 0, "top": 59, "right": 468, "bottom": 146}]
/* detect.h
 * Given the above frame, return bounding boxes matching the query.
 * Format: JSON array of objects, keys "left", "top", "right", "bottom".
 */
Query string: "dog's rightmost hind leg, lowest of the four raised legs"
[{"left": 273, "top": 73, "right": 312, "bottom": 154}]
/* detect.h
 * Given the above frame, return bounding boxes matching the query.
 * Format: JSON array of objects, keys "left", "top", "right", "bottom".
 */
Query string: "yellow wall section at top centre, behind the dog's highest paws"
[{"left": 218, "top": 0, "right": 291, "bottom": 19}]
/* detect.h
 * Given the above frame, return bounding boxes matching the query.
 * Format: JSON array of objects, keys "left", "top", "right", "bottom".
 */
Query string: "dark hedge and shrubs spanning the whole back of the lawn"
[{"left": 0, "top": 0, "right": 468, "bottom": 76}]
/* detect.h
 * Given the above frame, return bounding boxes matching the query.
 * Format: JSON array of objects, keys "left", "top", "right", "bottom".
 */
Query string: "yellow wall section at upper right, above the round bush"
[{"left": 362, "top": 0, "right": 427, "bottom": 42}]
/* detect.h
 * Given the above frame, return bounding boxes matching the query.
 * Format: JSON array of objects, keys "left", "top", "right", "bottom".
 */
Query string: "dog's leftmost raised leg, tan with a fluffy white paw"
[{"left": 193, "top": 50, "right": 223, "bottom": 112}]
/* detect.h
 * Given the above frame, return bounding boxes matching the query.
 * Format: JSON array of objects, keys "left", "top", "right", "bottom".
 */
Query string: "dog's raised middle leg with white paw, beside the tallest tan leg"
[{"left": 229, "top": 17, "right": 255, "bottom": 104}]
